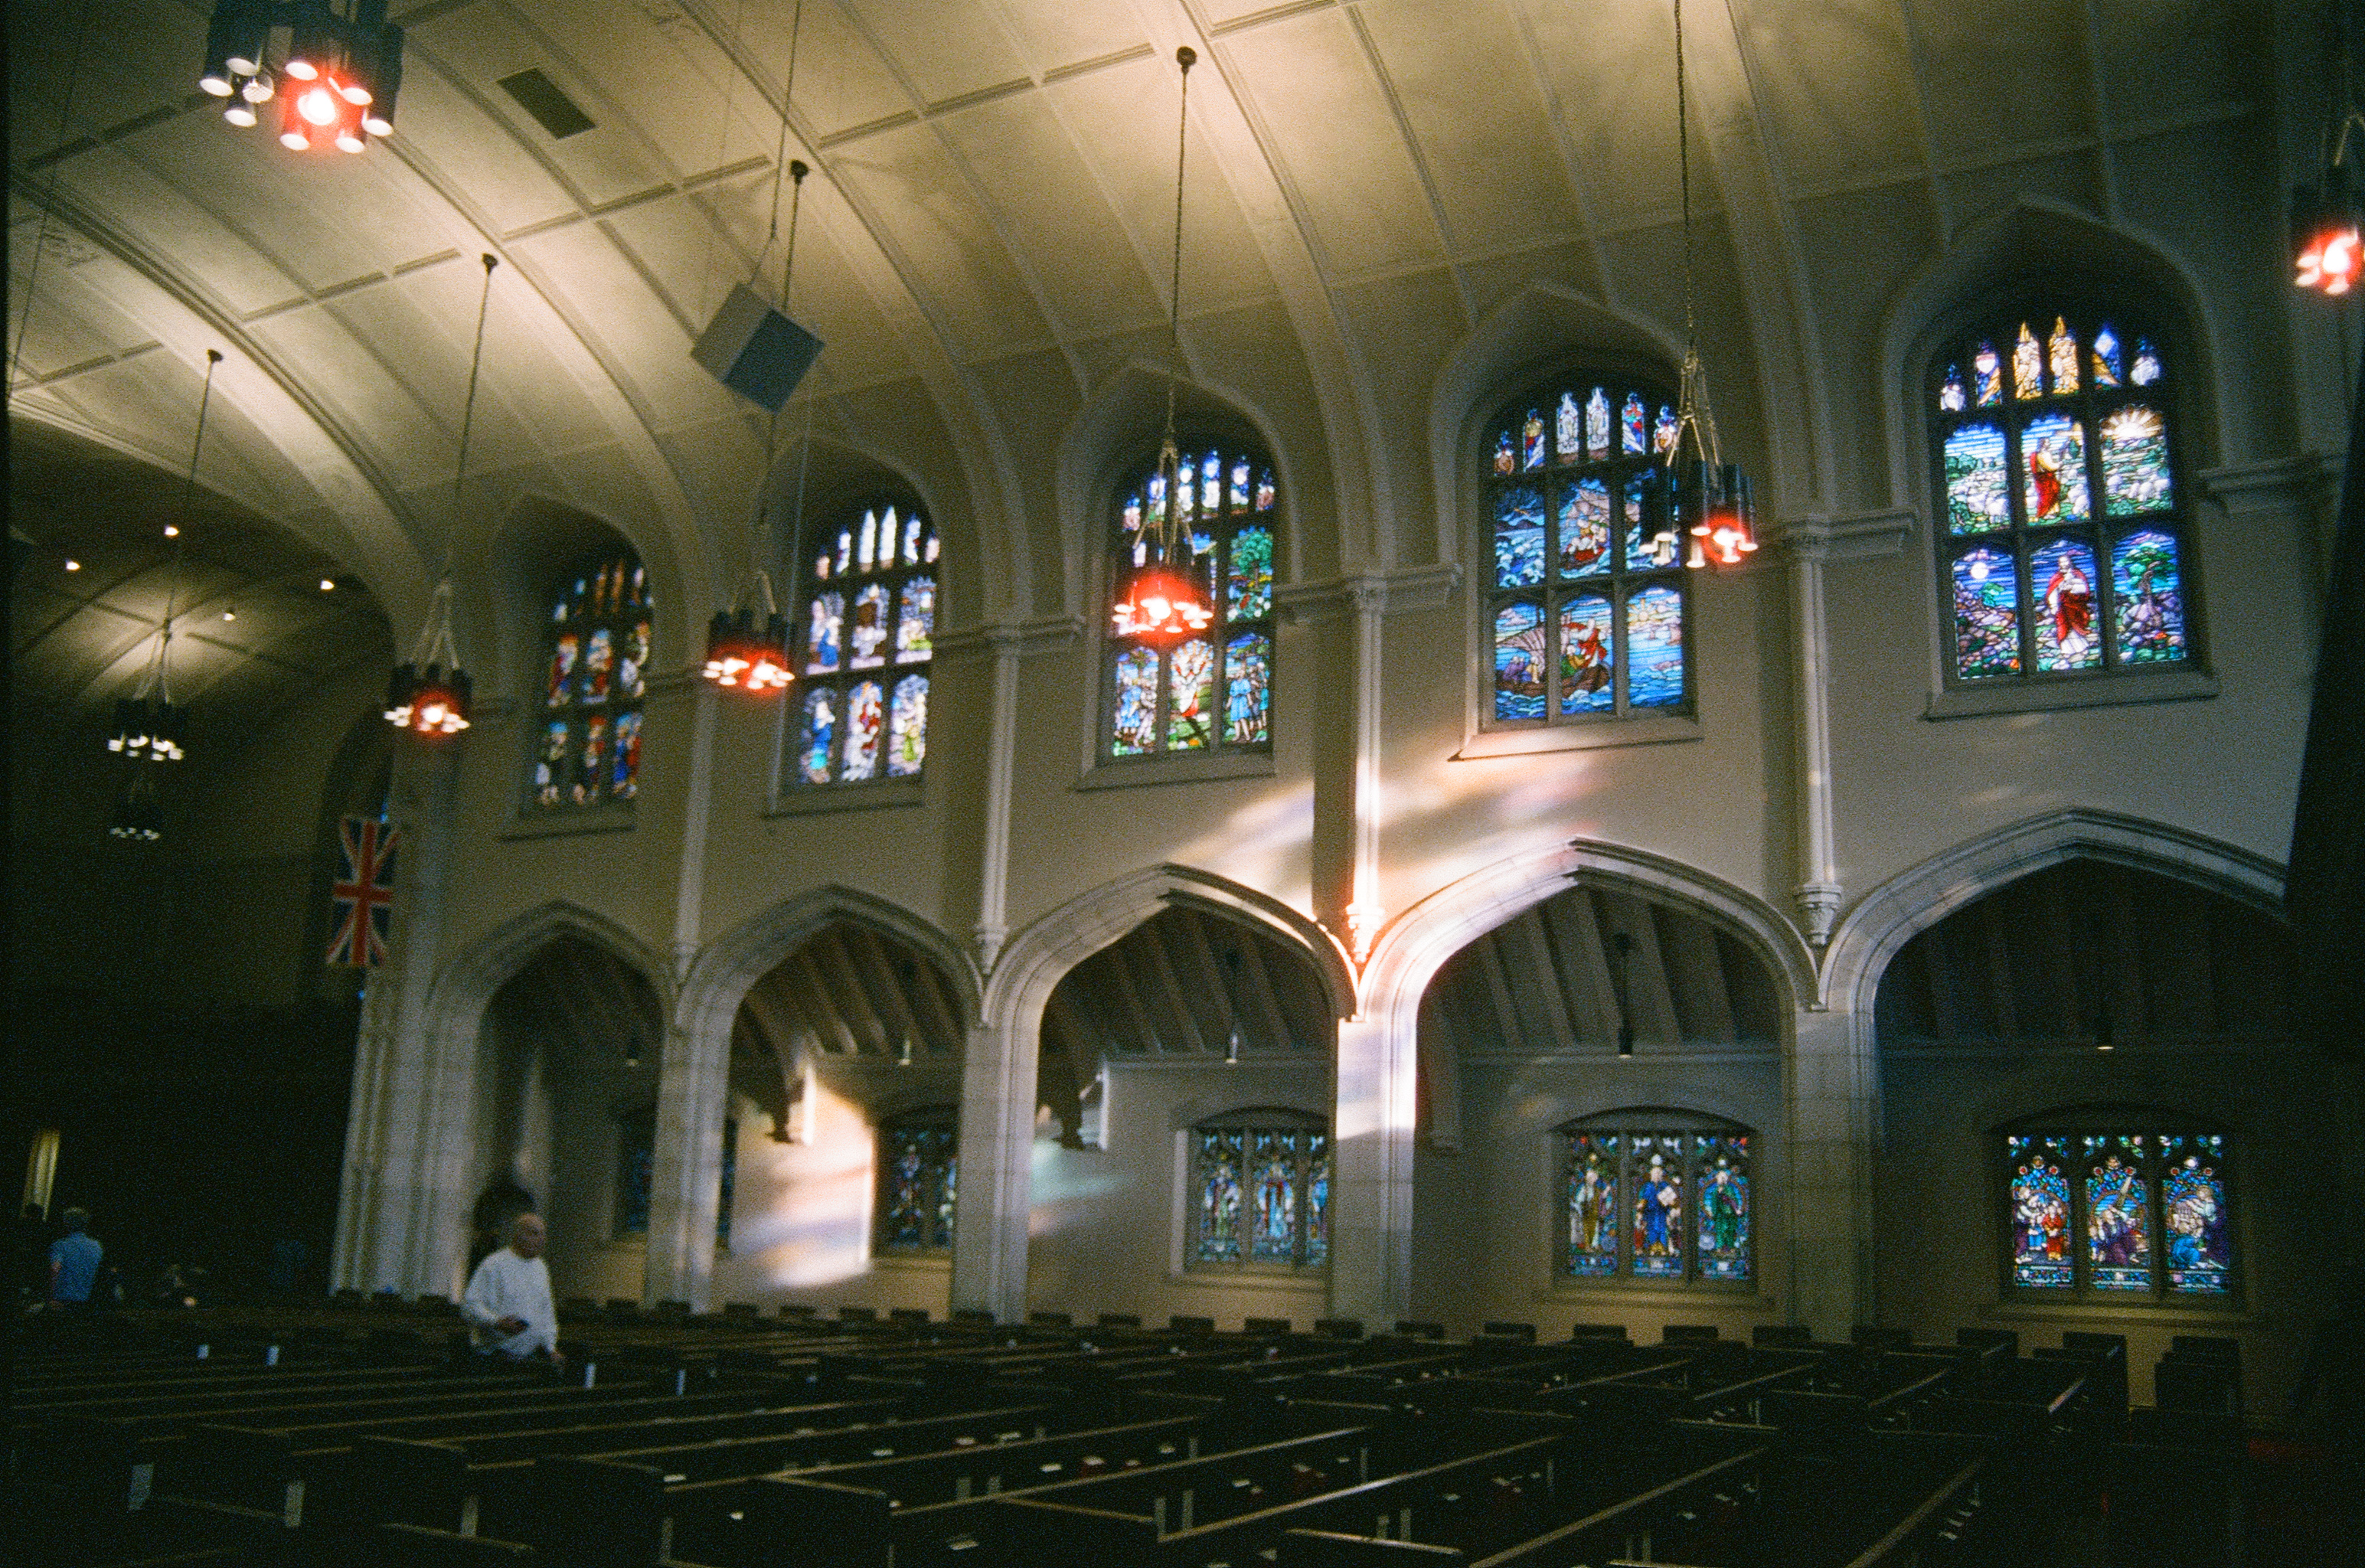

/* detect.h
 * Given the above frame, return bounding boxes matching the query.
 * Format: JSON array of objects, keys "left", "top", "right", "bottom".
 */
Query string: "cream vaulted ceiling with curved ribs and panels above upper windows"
[{"left": 7, "top": 0, "right": 2320, "bottom": 709}]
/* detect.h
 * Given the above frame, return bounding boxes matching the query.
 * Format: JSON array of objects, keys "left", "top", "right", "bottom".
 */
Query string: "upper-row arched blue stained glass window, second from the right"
[{"left": 1485, "top": 378, "right": 1691, "bottom": 728}]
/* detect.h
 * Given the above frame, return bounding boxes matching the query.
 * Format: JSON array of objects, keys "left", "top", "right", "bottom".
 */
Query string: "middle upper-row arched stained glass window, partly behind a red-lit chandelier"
[{"left": 1102, "top": 445, "right": 1279, "bottom": 762}]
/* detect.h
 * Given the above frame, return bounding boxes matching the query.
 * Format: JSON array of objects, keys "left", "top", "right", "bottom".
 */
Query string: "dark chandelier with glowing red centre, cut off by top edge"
[{"left": 196, "top": 0, "right": 402, "bottom": 152}]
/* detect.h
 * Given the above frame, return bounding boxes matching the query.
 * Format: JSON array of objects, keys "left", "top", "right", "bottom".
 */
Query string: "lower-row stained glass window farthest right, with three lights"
[{"left": 2003, "top": 1125, "right": 2233, "bottom": 1301}]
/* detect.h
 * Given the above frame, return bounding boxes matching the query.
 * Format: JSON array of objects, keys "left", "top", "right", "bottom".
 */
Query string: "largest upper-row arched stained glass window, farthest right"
[{"left": 1930, "top": 310, "right": 2193, "bottom": 686}]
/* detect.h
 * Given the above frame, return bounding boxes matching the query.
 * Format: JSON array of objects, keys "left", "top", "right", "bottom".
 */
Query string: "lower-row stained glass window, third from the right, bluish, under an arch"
[{"left": 1190, "top": 1109, "right": 1331, "bottom": 1268}]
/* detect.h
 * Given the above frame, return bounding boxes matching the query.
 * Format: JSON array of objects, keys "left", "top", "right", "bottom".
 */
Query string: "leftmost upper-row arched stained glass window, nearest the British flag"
[{"left": 528, "top": 554, "right": 650, "bottom": 816}]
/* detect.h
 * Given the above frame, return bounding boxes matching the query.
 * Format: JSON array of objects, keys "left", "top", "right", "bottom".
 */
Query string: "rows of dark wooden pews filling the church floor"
[{"left": 9, "top": 1303, "right": 2242, "bottom": 1568}]
